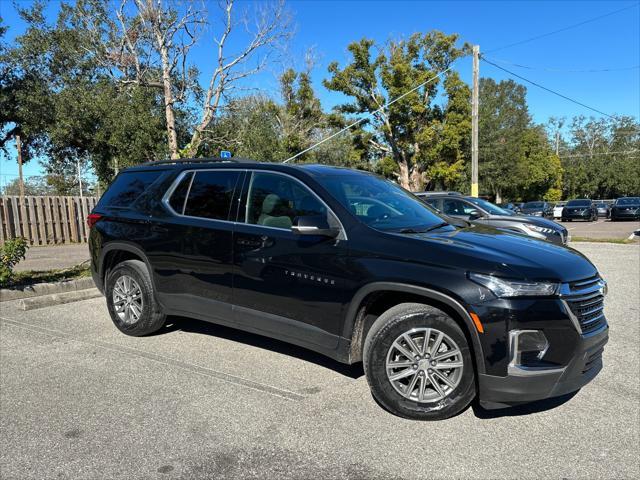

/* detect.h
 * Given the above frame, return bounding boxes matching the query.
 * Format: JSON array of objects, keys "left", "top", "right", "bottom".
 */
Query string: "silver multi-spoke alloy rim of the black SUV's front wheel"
[{"left": 385, "top": 328, "right": 464, "bottom": 403}]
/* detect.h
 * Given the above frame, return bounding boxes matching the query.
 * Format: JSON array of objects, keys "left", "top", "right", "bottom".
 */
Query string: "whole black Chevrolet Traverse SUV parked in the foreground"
[{"left": 87, "top": 160, "right": 608, "bottom": 420}]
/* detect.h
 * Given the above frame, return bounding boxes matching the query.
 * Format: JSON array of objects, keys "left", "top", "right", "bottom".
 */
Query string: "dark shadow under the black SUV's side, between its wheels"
[{"left": 155, "top": 316, "right": 364, "bottom": 379}]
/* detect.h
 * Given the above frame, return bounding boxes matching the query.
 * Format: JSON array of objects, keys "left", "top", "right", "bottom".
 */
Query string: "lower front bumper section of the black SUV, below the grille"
[{"left": 478, "top": 324, "right": 609, "bottom": 408}]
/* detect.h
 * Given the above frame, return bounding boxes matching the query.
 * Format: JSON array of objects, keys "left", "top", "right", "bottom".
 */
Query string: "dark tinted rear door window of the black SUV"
[{"left": 184, "top": 170, "right": 240, "bottom": 220}]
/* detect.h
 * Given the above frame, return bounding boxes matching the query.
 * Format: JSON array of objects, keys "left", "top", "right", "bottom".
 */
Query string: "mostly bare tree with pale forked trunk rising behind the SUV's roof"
[{"left": 74, "top": 0, "right": 290, "bottom": 158}]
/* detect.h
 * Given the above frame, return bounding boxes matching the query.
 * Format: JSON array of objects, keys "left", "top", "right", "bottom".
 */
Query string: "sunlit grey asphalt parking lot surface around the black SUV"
[{"left": 0, "top": 243, "right": 640, "bottom": 479}]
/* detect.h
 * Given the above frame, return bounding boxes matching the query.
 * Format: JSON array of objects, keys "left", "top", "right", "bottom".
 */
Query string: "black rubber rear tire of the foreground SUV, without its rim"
[{"left": 105, "top": 260, "right": 166, "bottom": 337}]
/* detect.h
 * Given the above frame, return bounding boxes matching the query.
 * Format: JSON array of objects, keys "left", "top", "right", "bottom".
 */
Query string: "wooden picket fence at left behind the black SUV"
[{"left": 0, "top": 196, "right": 97, "bottom": 245}]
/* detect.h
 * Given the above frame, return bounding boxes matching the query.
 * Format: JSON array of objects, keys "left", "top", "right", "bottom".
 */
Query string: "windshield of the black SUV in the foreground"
[{"left": 317, "top": 173, "right": 444, "bottom": 231}]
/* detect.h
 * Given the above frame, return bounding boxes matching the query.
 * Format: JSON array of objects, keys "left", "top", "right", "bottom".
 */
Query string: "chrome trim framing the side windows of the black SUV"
[{"left": 161, "top": 168, "right": 348, "bottom": 240}]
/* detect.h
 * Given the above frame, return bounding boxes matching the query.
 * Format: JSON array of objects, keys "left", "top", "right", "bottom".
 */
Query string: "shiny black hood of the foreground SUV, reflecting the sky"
[{"left": 408, "top": 225, "right": 598, "bottom": 282}]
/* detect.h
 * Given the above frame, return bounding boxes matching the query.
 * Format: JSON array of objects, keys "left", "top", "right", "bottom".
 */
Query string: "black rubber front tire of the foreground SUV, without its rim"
[{"left": 363, "top": 303, "right": 476, "bottom": 420}]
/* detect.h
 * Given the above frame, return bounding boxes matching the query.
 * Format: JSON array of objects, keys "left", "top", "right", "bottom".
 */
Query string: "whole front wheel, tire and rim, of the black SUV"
[{"left": 363, "top": 303, "right": 476, "bottom": 420}]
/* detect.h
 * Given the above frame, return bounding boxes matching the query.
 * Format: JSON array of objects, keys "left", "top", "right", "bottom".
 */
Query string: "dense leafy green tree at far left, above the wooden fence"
[{"left": 0, "top": 3, "right": 178, "bottom": 186}]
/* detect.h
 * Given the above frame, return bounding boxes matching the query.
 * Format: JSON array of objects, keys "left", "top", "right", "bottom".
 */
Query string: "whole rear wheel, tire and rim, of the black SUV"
[{"left": 105, "top": 260, "right": 166, "bottom": 337}]
